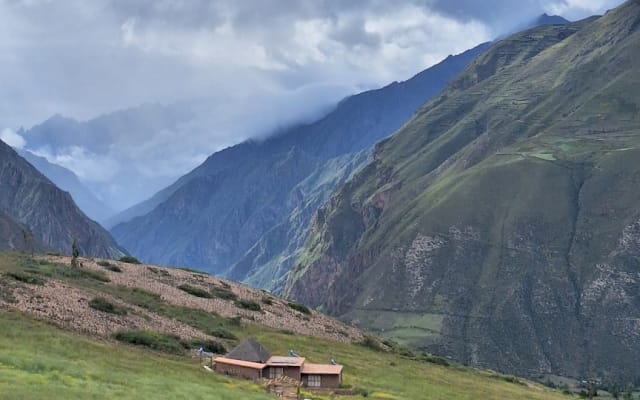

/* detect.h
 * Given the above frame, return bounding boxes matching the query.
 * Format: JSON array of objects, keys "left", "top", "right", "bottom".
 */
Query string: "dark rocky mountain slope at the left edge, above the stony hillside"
[{"left": 0, "top": 141, "right": 124, "bottom": 257}]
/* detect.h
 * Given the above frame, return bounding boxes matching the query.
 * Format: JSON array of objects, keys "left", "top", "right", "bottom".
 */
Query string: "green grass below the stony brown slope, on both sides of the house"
[{"left": 0, "top": 311, "right": 565, "bottom": 400}]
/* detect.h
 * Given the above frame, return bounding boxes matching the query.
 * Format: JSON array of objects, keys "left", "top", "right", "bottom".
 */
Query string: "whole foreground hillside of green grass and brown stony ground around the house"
[{"left": 0, "top": 253, "right": 564, "bottom": 399}]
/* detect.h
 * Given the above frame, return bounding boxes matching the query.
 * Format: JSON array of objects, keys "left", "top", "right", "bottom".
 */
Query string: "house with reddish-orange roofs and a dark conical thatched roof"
[{"left": 213, "top": 338, "right": 343, "bottom": 388}]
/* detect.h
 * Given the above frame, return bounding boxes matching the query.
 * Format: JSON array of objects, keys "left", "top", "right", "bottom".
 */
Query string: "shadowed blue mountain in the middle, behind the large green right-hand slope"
[{"left": 112, "top": 45, "right": 487, "bottom": 290}]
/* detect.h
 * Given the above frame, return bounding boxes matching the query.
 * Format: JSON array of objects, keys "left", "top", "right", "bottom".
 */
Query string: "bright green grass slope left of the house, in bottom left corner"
[{"left": 0, "top": 311, "right": 272, "bottom": 400}]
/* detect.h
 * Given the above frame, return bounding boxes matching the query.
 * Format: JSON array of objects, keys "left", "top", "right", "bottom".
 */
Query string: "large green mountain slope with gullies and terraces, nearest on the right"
[{"left": 286, "top": 1, "right": 640, "bottom": 384}]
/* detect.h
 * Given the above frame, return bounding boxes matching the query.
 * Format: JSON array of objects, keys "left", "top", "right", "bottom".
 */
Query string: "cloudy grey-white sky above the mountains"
[{"left": 0, "top": 0, "right": 622, "bottom": 211}]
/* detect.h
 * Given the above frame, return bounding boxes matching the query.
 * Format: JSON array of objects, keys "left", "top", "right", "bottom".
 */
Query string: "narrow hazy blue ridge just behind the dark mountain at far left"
[{"left": 18, "top": 151, "right": 113, "bottom": 222}]
